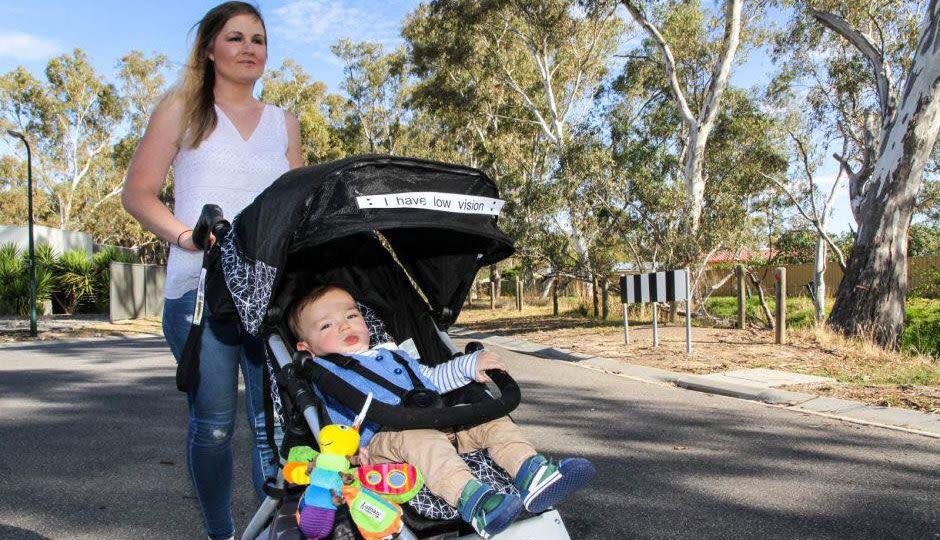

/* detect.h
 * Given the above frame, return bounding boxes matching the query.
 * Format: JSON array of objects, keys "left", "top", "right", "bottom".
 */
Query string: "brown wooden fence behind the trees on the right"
[{"left": 700, "top": 256, "right": 940, "bottom": 296}]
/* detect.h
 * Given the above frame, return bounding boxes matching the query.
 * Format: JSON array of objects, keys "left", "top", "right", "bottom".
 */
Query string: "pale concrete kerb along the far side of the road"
[{"left": 449, "top": 326, "right": 940, "bottom": 439}]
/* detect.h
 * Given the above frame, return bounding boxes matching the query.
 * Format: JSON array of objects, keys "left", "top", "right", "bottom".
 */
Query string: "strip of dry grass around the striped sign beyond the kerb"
[{"left": 458, "top": 298, "right": 940, "bottom": 414}]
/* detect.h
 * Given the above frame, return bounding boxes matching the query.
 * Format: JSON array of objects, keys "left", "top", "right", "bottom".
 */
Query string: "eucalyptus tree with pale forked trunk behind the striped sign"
[{"left": 608, "top": 2, "right": 786, "bottom": 290}]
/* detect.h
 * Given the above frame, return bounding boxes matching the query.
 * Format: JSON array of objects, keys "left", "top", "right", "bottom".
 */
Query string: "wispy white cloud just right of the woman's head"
[{"left": 272, "top": 0, "right": 402, "bottom": 52}]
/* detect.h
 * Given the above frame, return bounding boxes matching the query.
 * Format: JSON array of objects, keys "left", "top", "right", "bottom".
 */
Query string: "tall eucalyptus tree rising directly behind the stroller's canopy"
[{"left": 404, "top": 0, "right": 622, "bottom": 286}]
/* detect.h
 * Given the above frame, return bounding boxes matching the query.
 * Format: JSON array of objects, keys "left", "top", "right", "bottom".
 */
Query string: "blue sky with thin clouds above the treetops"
[{"left": 0, "top": 0, "right": 852, "bottom": 233}]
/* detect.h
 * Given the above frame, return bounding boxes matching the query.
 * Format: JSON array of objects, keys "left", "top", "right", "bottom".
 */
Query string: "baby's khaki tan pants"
[{"left": 366, "top": 416, "right": 537, "bottom": 507}]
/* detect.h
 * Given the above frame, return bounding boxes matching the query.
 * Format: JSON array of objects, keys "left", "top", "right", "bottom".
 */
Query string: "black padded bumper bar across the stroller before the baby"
[{"left": 305, "top": 362, "right": 522, "bottom": 429}]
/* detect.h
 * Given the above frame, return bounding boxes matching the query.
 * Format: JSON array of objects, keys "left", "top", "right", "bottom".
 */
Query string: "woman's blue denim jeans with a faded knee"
[{"left": 163, "top": 290, "right": 277, "bottom": 539}]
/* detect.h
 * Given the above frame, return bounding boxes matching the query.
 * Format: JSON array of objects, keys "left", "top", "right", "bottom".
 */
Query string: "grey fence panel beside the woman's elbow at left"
[{"left": 110, "top": 262, "right": 166, "bottom": 321}]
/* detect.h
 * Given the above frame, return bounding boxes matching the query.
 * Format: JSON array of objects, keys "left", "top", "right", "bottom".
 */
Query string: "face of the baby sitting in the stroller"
[{"left": 297, "top": 289, "right": 369, "bottom": 356}]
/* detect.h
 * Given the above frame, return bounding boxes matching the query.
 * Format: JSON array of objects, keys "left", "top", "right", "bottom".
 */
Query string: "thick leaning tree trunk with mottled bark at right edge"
[{"left": 829, "top": 0, "right": 940, "bottom": 349}]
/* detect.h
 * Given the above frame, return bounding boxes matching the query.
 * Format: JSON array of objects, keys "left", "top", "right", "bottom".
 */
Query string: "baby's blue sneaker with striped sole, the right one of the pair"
[{"left": 514, "top": 455, "right": 597, "bottom": 514}]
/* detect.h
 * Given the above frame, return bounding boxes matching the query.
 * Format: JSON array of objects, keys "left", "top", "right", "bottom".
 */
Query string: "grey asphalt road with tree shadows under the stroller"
[{"left": 0, "top": 338, "right": 940, "bottom": 540}]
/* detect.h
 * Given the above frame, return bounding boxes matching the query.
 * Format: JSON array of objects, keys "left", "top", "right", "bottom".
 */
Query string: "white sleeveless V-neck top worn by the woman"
[{"left": 164, "top": 105, "right": 290, "bottom": 299}]
